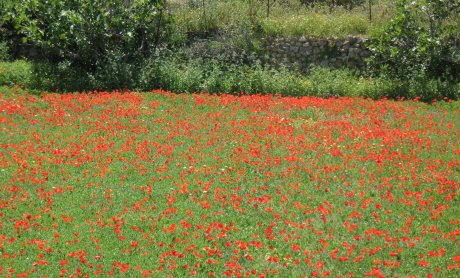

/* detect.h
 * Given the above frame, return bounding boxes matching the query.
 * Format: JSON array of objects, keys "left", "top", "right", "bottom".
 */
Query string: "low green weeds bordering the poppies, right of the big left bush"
[{"left": 138, "top": 57, "right": 460, "bottom": 101}]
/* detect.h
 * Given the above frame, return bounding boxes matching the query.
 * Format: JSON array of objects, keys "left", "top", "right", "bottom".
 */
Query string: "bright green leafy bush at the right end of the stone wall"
[{"left": 370, "top": 0, "right": 460, "bottom": 80}]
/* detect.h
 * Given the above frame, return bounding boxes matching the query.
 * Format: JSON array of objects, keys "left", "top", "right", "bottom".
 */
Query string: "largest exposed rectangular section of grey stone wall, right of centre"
[{"left": 264, "top": 36, "right": 371, "bottom": 71}]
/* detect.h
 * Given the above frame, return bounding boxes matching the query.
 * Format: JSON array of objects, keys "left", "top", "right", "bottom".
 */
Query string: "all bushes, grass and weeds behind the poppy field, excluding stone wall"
[{"left": 0, "top": 0, "right": 460, "bottom": 100}]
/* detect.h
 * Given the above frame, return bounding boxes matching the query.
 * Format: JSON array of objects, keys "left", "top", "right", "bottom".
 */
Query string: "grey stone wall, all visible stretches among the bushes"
[{"left": 10, "top": 36, "right": 371, "bottom": 72}]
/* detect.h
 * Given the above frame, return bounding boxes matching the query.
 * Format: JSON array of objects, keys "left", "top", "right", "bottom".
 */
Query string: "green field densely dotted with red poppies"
[{"left": 0, "top": 87, "right": 460, "bottom": 277}]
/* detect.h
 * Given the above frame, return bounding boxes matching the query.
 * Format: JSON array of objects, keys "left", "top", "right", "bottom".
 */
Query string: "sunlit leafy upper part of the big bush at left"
[{"left": 11, "top": 0, "right": 167, "bottom": 62}]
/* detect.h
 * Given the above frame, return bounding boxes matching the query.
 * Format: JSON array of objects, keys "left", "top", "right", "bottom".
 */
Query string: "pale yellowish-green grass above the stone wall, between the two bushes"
[{"left": 171, "top": 0, "right": 394, "bottom": 37}]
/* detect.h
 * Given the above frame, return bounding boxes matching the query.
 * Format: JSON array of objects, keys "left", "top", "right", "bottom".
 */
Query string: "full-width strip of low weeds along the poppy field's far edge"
[{"left": 0, "top": 56, "right": 460, "bottom": 101}]
